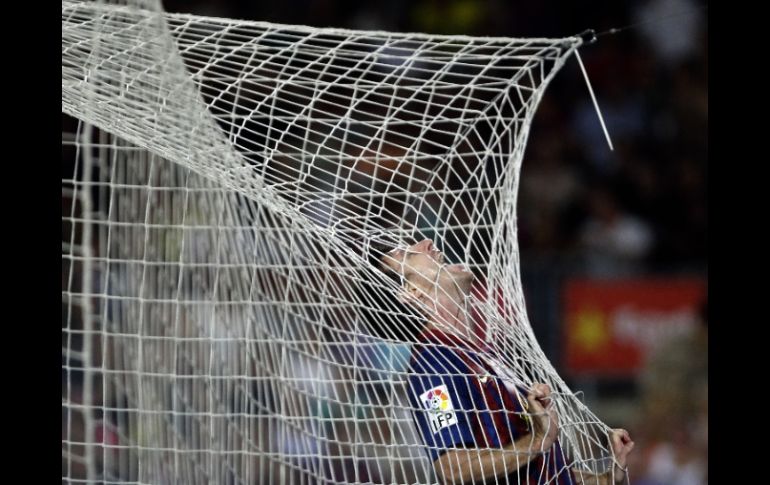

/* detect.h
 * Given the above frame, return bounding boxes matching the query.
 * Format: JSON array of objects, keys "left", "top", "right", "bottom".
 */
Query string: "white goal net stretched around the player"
[{"left": 62, "top": 1, "right": 607, "bottom": 484}]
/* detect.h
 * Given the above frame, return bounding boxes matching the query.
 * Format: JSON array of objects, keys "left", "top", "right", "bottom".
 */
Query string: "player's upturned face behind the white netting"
[{"left": 383, "top": 239, "right": 473, "bottom": 295}]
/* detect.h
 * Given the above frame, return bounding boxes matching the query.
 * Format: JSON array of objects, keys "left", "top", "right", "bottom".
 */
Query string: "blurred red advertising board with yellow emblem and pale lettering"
[{"left": 563, "top": 279, "right": 706, "bottom": 376}]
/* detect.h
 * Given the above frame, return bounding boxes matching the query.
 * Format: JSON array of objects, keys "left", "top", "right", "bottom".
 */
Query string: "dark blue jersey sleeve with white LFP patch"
[{"left": 409, "top": 347, "right": 476, "bottom": 462}]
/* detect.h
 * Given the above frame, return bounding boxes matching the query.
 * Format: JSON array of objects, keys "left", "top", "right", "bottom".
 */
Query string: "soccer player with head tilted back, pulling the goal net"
[{"left": 372, "top": 239, "right": 634, "bottom": 485}]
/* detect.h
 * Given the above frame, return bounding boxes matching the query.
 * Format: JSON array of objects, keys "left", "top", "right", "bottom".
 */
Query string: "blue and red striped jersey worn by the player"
[{"left": 408, "top": 330, "right": 575, "bottom": 485}]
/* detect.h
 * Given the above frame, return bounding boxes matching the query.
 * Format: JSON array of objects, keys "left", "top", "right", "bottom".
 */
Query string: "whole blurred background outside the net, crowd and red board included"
[{"left": 64, "top": 0, "right": 708, "bottom": 485}]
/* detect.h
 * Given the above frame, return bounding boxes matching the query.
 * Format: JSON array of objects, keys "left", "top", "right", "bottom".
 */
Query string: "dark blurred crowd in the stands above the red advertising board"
[{"left": 164, "top": 0, "right": 708, "bottom": 276}]
